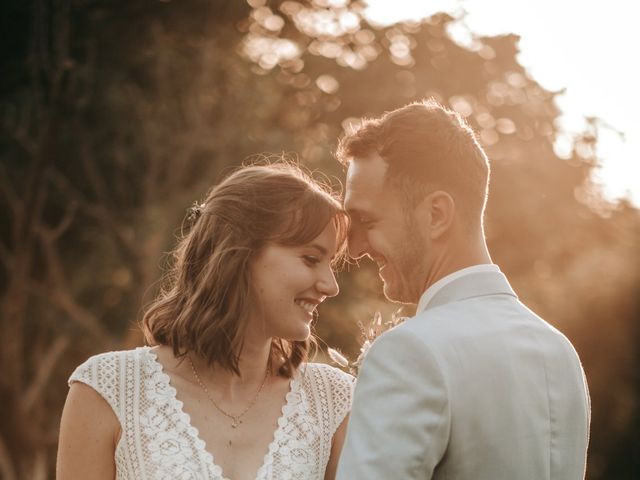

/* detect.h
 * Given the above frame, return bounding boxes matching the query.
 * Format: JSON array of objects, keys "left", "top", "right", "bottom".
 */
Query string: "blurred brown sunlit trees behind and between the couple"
[{"left": 0, "top": 0, "right": 640, "bottom": 480}]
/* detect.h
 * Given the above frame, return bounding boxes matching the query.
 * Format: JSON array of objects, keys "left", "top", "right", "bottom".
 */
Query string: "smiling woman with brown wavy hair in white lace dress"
[{"left": 57, "top": 163, "right": 353, "bottom": 480}]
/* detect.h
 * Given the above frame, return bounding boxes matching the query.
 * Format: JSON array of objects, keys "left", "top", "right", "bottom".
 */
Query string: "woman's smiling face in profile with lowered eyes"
[{"left": 249, "top": 222, "right": 339, "bottom": 340}]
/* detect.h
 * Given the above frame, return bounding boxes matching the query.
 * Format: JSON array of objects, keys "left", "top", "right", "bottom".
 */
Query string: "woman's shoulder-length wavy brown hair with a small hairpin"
[{"left": 142, "top": 161, "right": 348, "bottom": 377}]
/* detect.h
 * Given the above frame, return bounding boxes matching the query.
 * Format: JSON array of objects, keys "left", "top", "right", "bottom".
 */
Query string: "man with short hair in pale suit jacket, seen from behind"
[{"left": 337, "top": 101, "right": 590, "bottom": 480}]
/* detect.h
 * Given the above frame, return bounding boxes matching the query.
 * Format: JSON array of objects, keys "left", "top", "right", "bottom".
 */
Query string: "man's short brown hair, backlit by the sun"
[{"left": 336, "top": 99, "right": 489, "bottom": 225}]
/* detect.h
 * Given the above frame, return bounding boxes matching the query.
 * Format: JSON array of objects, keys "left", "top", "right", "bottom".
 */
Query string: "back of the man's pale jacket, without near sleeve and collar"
[{"left": 410, "top": 295, "right": 589, "bottom": 480}]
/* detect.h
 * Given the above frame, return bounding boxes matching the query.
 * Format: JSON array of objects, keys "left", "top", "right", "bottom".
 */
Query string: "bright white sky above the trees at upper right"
[{"left": 366, "top": 0, "right": 640, "bottom": 206}]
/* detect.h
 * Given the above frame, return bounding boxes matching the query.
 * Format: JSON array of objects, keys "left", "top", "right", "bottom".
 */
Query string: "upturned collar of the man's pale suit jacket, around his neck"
[{"left": 416, "top": 269, "right": 517, "bottom": 313}]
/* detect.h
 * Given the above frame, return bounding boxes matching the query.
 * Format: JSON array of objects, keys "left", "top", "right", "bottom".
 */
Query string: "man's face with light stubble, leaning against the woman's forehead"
[{"left": 345, "top": 153, "right": 427, "bottom": 303}]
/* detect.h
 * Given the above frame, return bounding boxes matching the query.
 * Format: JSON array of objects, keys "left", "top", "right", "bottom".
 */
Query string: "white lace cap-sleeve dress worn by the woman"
[{"left": 69, "top": 347, "right": 353, "bottom": 480}]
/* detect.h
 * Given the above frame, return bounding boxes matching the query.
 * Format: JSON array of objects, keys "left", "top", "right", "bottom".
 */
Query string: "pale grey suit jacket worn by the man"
[{"left": 337, "top": 272, "right": 590, "bottom": 480}]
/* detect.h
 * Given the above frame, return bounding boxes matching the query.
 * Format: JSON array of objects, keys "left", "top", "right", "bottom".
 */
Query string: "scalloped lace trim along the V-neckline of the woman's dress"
[{"left": 144, "top": 346, "right": 300, "bottom": 480}]
